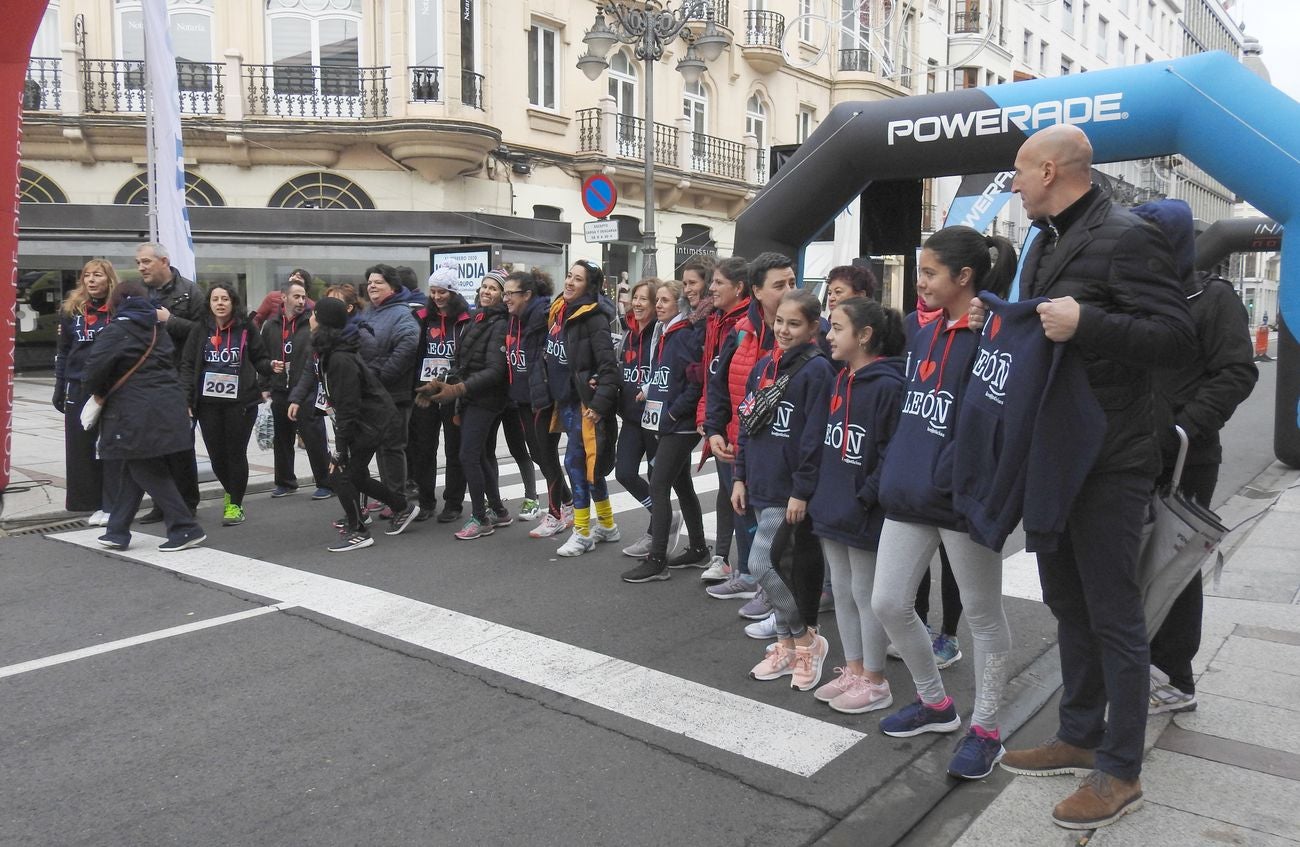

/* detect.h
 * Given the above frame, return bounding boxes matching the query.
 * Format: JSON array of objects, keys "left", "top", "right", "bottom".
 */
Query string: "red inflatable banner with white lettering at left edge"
[{"left": 0, "top": 0, "right": 46, "bottom": 491}]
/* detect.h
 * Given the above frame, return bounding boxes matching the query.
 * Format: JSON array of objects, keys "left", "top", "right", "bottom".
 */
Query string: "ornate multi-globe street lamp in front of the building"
[{"left": 577, "top": 0, "right": 731, "bottom": 277}]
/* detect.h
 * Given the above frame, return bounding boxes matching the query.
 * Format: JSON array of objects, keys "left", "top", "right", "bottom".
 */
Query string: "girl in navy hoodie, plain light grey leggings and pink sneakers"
[{"left": 809, "top": 297, "right": 906, "bottom": 714}]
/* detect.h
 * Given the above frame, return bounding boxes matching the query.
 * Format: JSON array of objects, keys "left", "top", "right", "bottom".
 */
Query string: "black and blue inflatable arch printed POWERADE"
[{"left": 736, "top": 52, "right": 1300, "bottom": 468}]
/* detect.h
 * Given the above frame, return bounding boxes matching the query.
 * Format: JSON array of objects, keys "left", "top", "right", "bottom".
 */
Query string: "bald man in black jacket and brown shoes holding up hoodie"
[{"left": 987, "top": 125, "right": 1196, "bottom": 829}]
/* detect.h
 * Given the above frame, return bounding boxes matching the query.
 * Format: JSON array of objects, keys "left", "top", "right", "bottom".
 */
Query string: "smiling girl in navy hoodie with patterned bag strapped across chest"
[{"left": 732, "top": 291, "right": 835, "bottom": 691}]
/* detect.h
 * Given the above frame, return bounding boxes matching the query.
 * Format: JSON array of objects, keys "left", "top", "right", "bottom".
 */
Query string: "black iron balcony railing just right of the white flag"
[{"left": 243, "top": 65, "right": 389, "bottom": 118}]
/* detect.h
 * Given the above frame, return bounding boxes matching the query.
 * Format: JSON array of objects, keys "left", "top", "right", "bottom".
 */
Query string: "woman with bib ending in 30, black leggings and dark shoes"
[{"left": 623, "top": 279, "right": 709, "bottom": 582}]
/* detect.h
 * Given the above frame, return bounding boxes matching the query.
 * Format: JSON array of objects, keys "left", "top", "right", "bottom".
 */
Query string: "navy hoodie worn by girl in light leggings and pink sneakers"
[{"left": 809, "top": 356, "right": 907, "bottom": 550}]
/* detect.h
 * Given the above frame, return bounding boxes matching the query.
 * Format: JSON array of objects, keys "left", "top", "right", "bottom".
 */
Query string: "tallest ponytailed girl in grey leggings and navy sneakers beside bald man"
[{"left": 871, "top": 226, "right": 1015, "bottom": 779}]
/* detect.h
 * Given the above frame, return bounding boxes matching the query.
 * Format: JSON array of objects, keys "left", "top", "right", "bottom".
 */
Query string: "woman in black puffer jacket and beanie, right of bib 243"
[{"left": 416, "top": 279, "right": 512, "bottom": 540}]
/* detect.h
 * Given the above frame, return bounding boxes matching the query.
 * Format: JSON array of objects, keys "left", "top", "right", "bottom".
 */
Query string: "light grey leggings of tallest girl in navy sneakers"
[{"left": 873, "top": 520, "right": 1011, "bottom": 730}]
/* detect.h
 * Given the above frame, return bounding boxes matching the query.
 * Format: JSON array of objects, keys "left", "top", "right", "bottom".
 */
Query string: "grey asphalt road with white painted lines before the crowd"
[{"left": 0, "top": 365, "right": 1273, "bottom": 846}]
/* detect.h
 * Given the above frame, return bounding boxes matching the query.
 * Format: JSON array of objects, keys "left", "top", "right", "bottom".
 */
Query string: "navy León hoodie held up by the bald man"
[{"left": 953, "top": 291, "right": 1106, "bottom": 552}]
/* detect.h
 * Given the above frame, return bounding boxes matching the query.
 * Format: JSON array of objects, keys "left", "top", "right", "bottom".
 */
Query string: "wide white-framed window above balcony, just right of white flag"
[{"left": 267, "top": 0, "right": 361, "bottom": 96}]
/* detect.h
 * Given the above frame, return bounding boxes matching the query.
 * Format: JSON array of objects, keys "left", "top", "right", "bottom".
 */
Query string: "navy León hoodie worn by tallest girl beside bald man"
[{"left": 880, "top": 310, "right": 979, "bottom": 533}]
